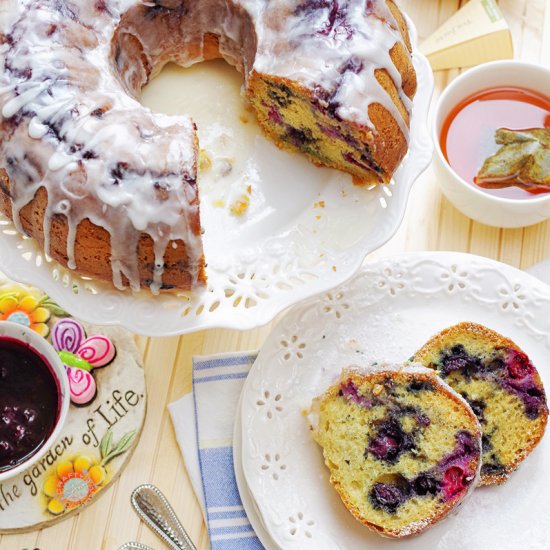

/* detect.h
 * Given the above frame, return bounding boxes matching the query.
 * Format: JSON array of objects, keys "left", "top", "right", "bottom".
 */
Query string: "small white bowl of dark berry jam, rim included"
[{"left": 0, "top": 321, "right": 70, "bottom": 483}]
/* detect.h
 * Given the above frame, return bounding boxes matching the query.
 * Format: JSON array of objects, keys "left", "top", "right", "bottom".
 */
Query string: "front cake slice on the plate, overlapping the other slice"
[{"left": 310, "top": 365, "right": 481, "bottom": 537}]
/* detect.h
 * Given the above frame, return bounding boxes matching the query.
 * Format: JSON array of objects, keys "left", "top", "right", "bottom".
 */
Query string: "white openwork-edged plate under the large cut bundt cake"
[{"left": 0, "top": 18, "right": 433, "bottom": 336}]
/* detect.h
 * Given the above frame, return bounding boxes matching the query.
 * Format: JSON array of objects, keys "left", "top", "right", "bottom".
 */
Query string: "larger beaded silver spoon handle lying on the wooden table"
[{"left": 131, "top": 484, "right": 197, "bottom": 550}]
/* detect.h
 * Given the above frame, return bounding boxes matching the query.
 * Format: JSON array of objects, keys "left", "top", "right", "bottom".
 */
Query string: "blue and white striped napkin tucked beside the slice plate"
[{"left": 168, "top": 352, "right": 264, "bottom": 550}]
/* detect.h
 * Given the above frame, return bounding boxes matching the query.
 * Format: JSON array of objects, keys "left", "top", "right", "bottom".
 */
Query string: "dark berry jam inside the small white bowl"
[{"left": 0, "top": 338, "right": 61, "bottom": 473}]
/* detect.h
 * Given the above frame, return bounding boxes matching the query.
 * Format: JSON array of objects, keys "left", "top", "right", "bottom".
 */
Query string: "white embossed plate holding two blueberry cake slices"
[{"left": 242, "top": 253, "right": 550, "bottom": 550}]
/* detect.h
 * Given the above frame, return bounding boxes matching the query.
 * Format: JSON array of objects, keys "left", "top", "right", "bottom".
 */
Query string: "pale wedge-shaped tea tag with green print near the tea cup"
[{"left": 420, "top": 0, "right": 514, "bottom": 71}]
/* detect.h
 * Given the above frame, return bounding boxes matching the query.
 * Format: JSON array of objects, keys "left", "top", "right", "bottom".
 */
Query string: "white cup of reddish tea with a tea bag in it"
[{"left": 433, "top": 61, "right": 550, "bottom": 227}]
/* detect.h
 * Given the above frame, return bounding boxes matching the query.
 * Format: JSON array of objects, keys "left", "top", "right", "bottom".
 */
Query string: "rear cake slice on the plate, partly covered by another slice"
[{"left": 414, "top": 323, "right": 548, "bottom": 485}]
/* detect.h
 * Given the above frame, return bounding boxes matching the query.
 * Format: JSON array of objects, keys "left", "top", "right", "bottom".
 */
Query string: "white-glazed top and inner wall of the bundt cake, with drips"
[{"left": 0, "top": 0, "right": 411, "bottom": 292}]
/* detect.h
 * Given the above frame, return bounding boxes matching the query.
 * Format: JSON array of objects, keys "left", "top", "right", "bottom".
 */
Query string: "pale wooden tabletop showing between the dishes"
[{"left": 0, "top": 0, "right": 550, "bottom": 550}]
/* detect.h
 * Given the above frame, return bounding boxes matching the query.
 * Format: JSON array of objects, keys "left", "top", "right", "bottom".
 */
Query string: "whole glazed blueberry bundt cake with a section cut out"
[{"left": 0, "top": 0, "right": 416, "bottom": 292}]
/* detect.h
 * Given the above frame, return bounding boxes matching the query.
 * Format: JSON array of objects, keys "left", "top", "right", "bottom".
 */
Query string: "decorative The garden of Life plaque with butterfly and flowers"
[{"left": 0, "top": 274, "right": 146, "bottom": 533}]
